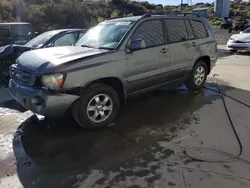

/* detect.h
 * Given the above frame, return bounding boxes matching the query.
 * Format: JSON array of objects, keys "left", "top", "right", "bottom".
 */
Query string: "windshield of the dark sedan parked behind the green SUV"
[{"left": 25, "top": 31, "right": 58, "bottom": 47}]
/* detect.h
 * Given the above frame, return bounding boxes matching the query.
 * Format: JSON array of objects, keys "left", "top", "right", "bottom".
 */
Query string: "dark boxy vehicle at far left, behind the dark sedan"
[{"left": 0, "top": 22, "right": 37, "bottom": 47}]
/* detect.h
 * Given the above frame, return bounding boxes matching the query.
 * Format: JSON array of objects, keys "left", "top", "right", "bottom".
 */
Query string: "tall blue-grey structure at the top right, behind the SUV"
[{"left": 214, "top": 0, "right": 231, "bottom": 18}]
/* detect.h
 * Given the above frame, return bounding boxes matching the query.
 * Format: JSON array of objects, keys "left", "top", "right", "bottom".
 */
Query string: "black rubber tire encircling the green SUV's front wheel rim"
[{"left": 72, "top": 83, "right": 120, "bottom": 129}]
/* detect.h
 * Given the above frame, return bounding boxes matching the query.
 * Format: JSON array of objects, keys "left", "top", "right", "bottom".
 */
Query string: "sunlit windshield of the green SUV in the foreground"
[{"left": 76, "top": 21, "right": 134, "bottom": 49}]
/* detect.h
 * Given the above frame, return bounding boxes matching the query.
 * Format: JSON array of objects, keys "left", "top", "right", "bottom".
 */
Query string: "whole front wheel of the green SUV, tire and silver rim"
[{"left": 72, "top": 84, "right": 120, "bottom": 129}]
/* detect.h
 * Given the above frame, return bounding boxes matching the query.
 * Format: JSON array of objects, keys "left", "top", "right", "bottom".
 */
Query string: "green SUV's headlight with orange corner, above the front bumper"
[{"left": 42, "top": 73, "right": 65, "bottom": 90}]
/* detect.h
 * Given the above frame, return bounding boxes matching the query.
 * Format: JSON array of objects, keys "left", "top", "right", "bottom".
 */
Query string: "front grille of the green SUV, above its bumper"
[{"left": 10, "top": 65, "right": 35, "bottom": 85}]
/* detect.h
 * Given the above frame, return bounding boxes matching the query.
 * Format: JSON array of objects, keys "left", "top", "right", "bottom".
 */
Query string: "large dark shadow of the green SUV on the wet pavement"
[{"left": 9, "top": 84, "right": 232, "bottom": 188}]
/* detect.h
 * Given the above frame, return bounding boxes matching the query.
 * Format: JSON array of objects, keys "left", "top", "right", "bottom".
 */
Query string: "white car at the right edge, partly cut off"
[{"left": 227, "top": 27, "right": 250, "bottom": 52}]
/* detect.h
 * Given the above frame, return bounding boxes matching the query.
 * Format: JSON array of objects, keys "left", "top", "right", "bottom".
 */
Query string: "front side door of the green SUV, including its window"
[{"left": 127, "top": 20, "right": 169, "bottom": 94}]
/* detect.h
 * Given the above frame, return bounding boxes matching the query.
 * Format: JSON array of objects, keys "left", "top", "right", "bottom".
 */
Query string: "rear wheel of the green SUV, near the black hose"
[{"left": 185, "top": 60, "right": 208, "bottom": 90}]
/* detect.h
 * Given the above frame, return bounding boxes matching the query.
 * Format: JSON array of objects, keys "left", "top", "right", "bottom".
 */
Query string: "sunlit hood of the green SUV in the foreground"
[{"left": 17, "top": 46, "right": 109, "bottom": 72}]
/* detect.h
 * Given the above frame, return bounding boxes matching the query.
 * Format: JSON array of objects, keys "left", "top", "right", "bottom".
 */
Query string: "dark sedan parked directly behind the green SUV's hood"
[{"left": 0, "top": 29, "right": 87, "bottom": 83}]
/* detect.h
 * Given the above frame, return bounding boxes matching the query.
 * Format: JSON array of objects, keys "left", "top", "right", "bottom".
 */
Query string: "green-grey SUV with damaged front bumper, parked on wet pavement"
[{"left": 9, "top": 14, "right": 217, "bottom": 128}]
